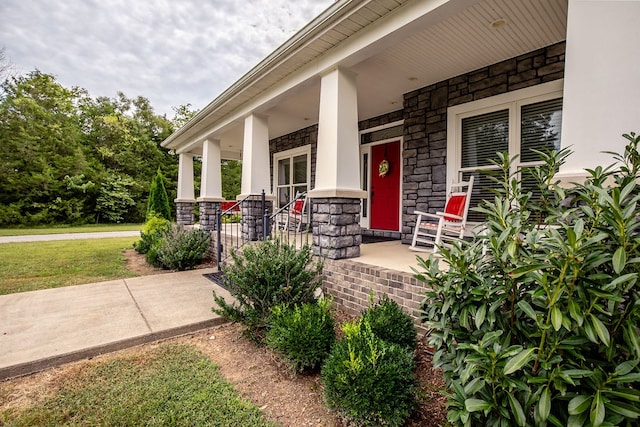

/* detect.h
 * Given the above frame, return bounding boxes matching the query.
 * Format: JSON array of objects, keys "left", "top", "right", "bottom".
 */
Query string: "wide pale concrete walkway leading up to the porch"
[{"left": 0, "top": 269, "right": 231, "bottom": 380}]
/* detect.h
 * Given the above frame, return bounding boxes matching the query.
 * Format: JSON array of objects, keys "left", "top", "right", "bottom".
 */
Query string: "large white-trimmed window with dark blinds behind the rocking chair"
[{"left": 447, "top": 81, "right": 562, "bottom": 221}]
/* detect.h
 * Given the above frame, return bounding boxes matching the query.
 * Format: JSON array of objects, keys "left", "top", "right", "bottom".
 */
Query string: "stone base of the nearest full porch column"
[{"left": 311, "top": 197, "right": 362, "bottom": 259}]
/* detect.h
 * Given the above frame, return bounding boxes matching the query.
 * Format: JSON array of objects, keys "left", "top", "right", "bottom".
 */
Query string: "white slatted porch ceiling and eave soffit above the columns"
[{"left": 170, "top": 0, "right": 567, "bottom": 157}]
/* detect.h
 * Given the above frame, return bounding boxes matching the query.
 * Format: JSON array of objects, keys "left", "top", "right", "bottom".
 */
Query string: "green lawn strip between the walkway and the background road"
[{"left": 0, "top": 237, "right": 138, "bottom": 295}]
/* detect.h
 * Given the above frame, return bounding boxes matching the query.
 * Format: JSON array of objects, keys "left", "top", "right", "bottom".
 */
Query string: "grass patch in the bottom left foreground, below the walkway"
[{"left": 0, "top": 345, "right": 275, "bottom": 427}]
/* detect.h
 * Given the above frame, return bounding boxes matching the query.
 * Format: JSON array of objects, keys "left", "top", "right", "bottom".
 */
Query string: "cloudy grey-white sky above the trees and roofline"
[{"left": 0, "top": 0, "right": 335, "bottom": 117}]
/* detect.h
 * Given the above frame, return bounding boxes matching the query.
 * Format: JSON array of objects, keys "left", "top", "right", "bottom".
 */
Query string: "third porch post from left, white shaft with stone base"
[{"left": 237, "top": 114, "right": 274, "bottom": 241}]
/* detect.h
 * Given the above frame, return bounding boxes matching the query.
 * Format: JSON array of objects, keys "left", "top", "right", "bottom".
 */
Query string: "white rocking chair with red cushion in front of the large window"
[{"left": 409, "top": 175, "right": 473, "bottom": 253}]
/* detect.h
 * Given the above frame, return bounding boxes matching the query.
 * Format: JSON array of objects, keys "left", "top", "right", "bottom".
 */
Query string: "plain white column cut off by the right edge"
[{"left": 559, "top": 0, "right": 640, "bottom": 180}]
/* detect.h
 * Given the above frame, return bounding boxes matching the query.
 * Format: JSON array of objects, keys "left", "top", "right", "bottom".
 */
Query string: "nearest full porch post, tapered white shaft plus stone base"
[{"left": 309, "top": 68, "right": 366, "bottom": 259}]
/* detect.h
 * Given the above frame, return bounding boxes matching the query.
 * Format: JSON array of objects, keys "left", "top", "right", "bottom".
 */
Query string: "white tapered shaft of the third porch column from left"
[{"left": 238, "top": 114, "right": 271, "bottom": 199}]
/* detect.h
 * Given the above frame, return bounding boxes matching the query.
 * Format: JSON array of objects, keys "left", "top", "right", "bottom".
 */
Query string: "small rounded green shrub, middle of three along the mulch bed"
[{"left": 266, "top": 298, "right": 336, "bottom": 372}]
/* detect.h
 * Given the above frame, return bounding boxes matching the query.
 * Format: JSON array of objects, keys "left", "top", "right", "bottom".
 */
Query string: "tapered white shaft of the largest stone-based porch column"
[{"left": 309, "top": 68, "right": 366, "bottom": 199}]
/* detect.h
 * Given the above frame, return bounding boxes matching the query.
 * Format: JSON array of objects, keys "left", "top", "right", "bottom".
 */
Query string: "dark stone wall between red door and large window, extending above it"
[{"left": 402, "top": 42, "right": 565, "bottom": 244}]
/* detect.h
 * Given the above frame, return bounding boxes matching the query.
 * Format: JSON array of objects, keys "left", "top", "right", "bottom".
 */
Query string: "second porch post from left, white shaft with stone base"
[{"left": 198, "top": 139, "right": 223, "bottom": 230}]
